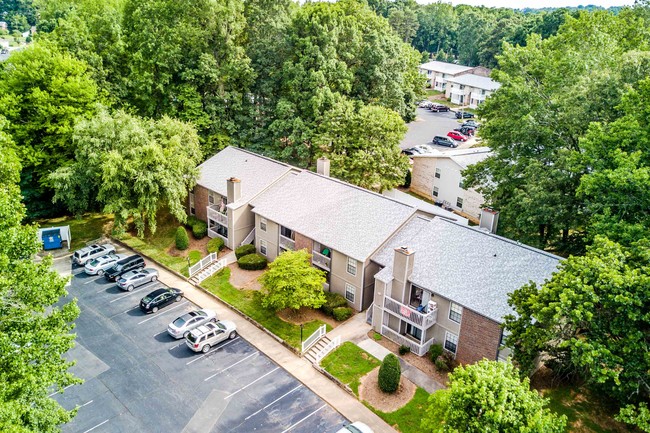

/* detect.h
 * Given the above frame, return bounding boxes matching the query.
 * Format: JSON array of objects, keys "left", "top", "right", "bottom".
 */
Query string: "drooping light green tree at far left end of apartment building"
[{"left": 50, "top": 109, "right": 201, "bottom": 237}]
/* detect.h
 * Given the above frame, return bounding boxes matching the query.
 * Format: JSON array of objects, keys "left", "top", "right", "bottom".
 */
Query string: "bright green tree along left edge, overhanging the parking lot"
[{"left": 0, "top": 116, "right": 80, "bottom": 433}]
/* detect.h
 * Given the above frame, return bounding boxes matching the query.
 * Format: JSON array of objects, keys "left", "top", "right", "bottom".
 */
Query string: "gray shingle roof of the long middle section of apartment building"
[{"left": 251, "top": 171, "right": 416, "bottom": 261}]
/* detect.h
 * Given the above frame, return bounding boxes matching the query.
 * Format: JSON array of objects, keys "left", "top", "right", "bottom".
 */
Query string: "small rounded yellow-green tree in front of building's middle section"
[{"left": 259, "top": 250, "right": 326, "bottom": 310}]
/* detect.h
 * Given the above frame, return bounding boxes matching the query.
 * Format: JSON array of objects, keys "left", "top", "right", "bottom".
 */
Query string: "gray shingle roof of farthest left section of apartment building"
[{"left": 197, "top": 146, "right": 292, "bottom": 205}]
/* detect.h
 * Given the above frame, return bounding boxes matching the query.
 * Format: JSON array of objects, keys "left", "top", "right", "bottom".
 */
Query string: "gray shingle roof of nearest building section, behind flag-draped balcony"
[{"left": 372, "top": 218, "right": 561, "bottom": 322}]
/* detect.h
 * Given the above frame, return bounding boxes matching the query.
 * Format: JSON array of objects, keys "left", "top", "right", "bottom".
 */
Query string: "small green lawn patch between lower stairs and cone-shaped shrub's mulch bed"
[{"left": 320, "top": 341, "right": 381, "bottom": 396}]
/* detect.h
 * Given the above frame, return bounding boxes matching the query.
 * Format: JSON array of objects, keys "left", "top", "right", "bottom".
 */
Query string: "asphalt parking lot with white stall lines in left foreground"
[{"left": 52, "top": 255, "right": 348, "bottom": 433}]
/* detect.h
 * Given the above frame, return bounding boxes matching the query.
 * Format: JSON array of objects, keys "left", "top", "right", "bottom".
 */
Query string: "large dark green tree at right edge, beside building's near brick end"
[{"left": 505, "top": 237, "right": 650, "bottom": 430}]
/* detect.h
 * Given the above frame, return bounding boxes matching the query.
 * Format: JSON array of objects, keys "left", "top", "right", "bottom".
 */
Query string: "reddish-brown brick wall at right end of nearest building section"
[{"left": 456, "top": 309, "right": 501, "bottom": 364}]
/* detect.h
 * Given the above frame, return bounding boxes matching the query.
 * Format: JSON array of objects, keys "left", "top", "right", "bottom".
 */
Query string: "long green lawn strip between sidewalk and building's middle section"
[{"left": 201, "top": 268, "right": 331, "bottom": 350}]
